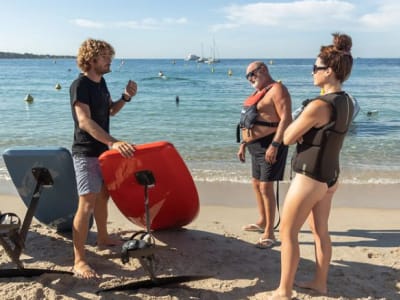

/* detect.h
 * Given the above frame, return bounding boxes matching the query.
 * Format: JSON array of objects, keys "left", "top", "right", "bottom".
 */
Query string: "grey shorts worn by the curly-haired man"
[{"left": 72, "top": 156, "right": 103, "bottom": 196}]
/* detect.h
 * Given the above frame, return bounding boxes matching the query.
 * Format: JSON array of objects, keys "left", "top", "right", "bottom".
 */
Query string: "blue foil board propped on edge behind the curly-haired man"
[{"left": 3, "top": 147, "right": 78, "bottom": 232}]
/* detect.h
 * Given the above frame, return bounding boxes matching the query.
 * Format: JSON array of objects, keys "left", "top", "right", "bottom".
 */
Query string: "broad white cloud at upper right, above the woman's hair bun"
[{"left": 212, "top": 0, "right": 400, "bottom": 31}]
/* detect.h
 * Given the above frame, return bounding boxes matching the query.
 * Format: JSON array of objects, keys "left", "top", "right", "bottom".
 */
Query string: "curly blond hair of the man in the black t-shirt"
[{"left": 76, "top": 38, "right": 115, "bottom": 72}]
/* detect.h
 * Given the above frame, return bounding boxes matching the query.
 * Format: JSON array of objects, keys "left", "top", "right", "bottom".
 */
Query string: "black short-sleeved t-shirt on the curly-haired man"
[{"left": 69, "top": 74, "right": 111, "bottom": 157}]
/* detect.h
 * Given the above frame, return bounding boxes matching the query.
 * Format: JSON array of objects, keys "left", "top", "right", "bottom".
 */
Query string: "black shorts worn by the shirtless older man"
[{"left": 247, "top": 133, "right": 288, "bottom": 182}]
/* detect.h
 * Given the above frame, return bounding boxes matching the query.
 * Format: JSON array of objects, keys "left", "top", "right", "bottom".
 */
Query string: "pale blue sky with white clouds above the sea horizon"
[{"left": 0, "top": 0, "right": 400, "bottom": 58}]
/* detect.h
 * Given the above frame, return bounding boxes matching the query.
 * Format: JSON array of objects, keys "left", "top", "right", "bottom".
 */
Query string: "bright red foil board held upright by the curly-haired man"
[{"left": 99, "top": 141, "right": 199, "bottom": 230}]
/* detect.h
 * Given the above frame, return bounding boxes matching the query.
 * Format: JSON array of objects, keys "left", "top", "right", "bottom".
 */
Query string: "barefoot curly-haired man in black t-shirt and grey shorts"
[{"left": 70, "top": 39, "right": 137, "bottom": 279}]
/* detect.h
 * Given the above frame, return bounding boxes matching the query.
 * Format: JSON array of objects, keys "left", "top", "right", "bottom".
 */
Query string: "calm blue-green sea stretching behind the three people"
[{"left": 0, "top": 59, "right": 400, "bottom": 184}]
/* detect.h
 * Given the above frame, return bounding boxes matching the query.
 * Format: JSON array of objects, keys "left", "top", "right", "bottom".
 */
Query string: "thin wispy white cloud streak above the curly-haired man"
[{"left": 71, "top": 17, "right": 188, "bottom": 30}]
